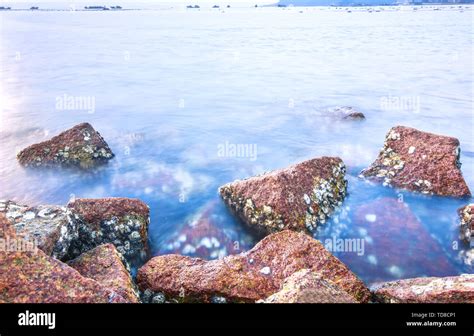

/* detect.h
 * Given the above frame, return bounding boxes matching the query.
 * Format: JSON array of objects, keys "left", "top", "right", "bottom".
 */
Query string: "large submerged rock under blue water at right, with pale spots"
[{"left": 342, "top": 197, "right": 457, "bottom": 281}]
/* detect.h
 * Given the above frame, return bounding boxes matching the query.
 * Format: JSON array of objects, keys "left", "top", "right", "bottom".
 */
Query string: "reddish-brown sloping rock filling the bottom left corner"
[{"left": 0, "top": 214, "right": 127, "bottom": 303}]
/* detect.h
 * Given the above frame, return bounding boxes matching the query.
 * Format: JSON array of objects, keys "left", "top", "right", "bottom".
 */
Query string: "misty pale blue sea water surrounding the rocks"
[{"left": 0, "top": 6, "right": 474, "bottom": 283}]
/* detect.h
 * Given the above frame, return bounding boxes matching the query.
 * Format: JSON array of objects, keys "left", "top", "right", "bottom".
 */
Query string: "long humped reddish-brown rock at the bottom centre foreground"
[{"left": 137, "top": 230, "right": 370, "bottom": 302}]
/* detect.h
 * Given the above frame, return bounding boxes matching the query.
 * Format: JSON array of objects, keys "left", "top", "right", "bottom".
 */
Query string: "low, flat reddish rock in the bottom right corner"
[{"left": 373, "top": 274, "right": 474, "bottom": 303}]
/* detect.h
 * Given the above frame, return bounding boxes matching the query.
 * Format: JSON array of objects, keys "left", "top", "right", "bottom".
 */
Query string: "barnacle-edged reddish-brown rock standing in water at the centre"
[{"left": 219, "top": 157, "right": 347, "bottom": 234}]
